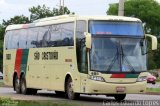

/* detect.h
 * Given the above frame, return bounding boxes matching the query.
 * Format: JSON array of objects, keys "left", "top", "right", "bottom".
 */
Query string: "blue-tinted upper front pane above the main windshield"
[{"left": 89, "top": 21, "right": 144, "bottom": 36}]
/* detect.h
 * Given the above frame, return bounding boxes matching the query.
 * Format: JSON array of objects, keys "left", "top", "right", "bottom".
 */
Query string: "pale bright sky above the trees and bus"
[{"left": 0, "top": 0, "right": 119, "bottom": 23}]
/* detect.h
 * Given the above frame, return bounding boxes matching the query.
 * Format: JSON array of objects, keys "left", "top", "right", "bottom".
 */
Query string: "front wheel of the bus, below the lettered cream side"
[{"left": 66, "top": 78, "right": 80, "bottom": 100}]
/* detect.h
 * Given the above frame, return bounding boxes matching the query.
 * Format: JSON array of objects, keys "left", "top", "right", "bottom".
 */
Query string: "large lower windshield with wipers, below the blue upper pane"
[{"left": 90, "top": 37, "right": 147, "bottom": 72}]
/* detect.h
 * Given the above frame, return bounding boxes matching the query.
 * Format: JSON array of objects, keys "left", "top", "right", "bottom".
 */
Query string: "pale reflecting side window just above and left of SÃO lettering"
[{"left": 27, "top": 27, "right": 39, "bottom": 48}]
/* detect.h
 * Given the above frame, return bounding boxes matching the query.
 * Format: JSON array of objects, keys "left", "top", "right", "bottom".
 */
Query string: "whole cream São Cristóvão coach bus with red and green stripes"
[{"left": 3, "top": 15, "right": 157, "bottom": 100}]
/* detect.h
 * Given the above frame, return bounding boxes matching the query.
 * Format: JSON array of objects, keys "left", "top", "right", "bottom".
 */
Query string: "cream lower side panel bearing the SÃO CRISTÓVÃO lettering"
[{"left": 26, "top": 47, "right": 80, "bottom": 92}]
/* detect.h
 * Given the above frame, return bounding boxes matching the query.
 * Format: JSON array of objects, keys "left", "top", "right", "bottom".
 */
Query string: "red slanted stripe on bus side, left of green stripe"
[{"left": 14, "top": 49, "right": 22, "bottom": 78}]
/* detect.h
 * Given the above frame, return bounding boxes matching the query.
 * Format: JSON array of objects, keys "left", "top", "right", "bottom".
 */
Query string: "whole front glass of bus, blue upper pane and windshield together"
[{"left": 89, "top": 21, "right": 147, "bottom": 72}]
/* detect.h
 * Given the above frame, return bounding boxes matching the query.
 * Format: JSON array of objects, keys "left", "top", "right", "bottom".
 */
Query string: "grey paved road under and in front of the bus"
[{"left": 0, "top": 87, "right": 160, "bottom": 106}]
